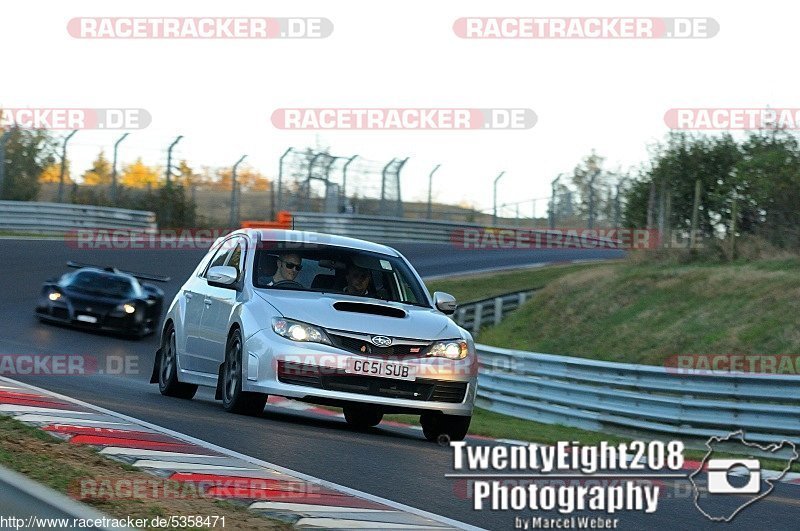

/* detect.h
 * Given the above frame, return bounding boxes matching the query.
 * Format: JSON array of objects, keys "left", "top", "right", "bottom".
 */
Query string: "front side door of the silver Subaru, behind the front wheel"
[{"left": 197, "top": 237, "right": 247, "bottom": 375}]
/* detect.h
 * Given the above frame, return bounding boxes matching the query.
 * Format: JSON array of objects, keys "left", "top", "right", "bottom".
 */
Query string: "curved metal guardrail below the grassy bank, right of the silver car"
[{"left": 476, "top": 345, "right": 800, "bottom": 443}]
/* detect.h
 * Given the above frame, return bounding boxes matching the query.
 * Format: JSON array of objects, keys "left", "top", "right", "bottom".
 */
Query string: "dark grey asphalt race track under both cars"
[{"left": 0, "top": 240, "right": 800, "bottom": 530}]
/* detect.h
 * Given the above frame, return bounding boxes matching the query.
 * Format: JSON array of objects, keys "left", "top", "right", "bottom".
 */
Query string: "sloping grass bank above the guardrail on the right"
[{"left": 476, "top": 258, "right": 800, "bottom": 365}]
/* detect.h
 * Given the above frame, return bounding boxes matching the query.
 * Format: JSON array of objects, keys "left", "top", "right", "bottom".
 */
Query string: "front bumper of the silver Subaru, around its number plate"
[{"left": 242, "top": 329, "right": 477, "bottom": 416}]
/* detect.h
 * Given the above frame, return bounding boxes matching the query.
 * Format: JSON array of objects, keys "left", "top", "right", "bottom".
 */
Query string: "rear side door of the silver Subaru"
[{"left": 187, "top": 243, "right": 231, "bottom": 372}]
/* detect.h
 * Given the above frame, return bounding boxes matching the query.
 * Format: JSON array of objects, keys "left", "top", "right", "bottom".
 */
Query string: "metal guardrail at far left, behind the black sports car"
[{"left": 0, "top": 201, "right": 158, "bottom": 234}]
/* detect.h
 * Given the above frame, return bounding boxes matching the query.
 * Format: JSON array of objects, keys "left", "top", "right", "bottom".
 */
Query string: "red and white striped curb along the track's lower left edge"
[{"left": 0, "top": 377, "right": 479, "bottom": 530}]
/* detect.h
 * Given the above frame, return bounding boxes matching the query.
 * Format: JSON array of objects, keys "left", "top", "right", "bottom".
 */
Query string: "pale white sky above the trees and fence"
[{"left": 0, "top": 0, "right": 800, "bottom": 215}]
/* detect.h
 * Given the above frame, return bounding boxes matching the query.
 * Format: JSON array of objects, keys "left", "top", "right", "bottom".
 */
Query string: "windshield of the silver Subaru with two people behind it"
[{"left": 253, "top": 246, "right": 428, "bottom": 306}]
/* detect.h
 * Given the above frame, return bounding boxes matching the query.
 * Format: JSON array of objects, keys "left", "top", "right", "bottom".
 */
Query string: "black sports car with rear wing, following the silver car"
[{"left": 36, "top": 262, "right": 169, "bottom": 337}]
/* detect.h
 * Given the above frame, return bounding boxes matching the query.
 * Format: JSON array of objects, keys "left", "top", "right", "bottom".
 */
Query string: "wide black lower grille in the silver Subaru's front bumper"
[{"left": 278, "top": 360, "right": 467, "bottom": 404}]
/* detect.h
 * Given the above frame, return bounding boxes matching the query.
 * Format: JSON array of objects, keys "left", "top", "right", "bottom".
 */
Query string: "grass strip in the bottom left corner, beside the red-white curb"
[{"left": 0, "top": 416, "right": 293, "bottom": 530}]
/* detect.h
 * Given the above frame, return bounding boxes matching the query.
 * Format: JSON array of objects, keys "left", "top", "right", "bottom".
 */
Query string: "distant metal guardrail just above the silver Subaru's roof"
[{"left": 292, "top": 212, "right": 620, "bottom": 249}]
